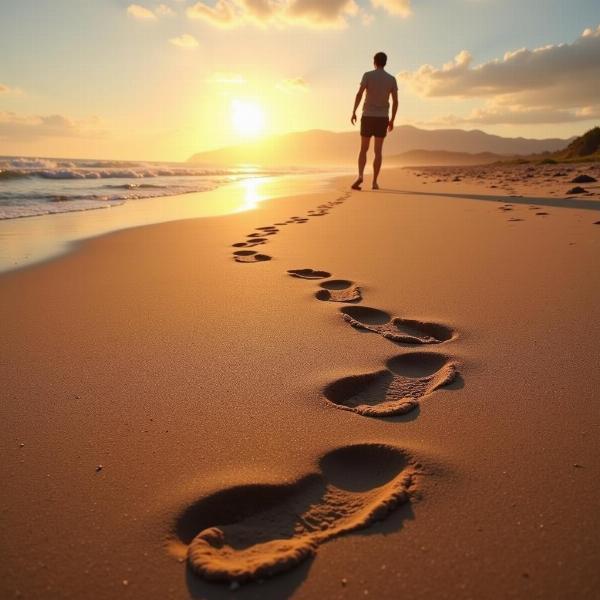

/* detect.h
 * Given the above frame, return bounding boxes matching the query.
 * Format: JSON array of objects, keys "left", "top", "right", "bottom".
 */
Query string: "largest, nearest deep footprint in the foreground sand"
[{"left": 174, "top": 444, "right": 419, "bottom": 583}]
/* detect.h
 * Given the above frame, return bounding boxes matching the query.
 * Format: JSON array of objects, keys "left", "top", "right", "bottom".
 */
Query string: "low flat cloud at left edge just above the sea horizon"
[{"left": 0, "top": 112, "right": 105, "bottom": 141}]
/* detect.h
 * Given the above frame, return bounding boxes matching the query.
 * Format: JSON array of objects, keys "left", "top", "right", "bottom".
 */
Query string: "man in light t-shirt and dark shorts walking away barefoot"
[{"left": 351, "top": 52, "right": 398, "bottom": 190}]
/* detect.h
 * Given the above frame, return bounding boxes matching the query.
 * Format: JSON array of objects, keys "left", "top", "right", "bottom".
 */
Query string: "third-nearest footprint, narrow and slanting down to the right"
[{"left": 340, "top": 306, "right": 455, "bottom": 344}]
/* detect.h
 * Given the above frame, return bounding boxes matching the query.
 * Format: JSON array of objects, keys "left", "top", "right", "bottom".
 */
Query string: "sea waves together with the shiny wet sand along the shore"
[{"left": 0, "top": 157, "right": 342, "bottom": 274}]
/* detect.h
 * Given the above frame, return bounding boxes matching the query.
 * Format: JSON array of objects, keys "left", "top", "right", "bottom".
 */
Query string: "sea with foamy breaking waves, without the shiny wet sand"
[{"left": 0, "top": 157, "right": 301, "bottom": 219}]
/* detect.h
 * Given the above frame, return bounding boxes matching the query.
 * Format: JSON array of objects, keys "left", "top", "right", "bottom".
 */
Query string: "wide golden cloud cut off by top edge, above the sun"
[{"left": 186, "top": 0, "right": 380, "bottom": 28}]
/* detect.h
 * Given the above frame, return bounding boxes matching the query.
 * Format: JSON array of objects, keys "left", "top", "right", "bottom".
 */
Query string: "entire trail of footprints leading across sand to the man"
[{"left": 175, "top": 194, "right": 462, "bottom": 585}]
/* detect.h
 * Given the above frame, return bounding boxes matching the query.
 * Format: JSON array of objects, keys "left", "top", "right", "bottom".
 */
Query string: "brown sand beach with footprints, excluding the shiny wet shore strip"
[{"left": 0, "top": 165, "right": 600, "bottom": 600}]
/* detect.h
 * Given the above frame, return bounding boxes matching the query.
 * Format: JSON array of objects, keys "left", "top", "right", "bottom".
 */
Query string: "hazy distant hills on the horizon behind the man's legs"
[{"left": 189, "top": 125, "right": 574, "bottom": 167}]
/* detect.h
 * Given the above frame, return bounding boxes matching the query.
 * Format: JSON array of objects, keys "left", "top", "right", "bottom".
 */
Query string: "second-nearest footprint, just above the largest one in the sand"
[{"left": 324, "top": 352, "right": 457, "bottom": 417}]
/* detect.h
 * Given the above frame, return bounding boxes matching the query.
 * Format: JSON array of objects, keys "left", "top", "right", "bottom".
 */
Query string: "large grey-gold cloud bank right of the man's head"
[{"left": 398, "top": 26, "right": 600, "bottom": 123}]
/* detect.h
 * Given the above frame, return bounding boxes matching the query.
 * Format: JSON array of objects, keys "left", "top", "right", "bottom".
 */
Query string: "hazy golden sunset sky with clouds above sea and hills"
[{"left": 0, "top": 0, "right": 600, "bottom": 161}]
